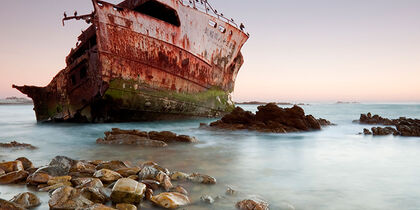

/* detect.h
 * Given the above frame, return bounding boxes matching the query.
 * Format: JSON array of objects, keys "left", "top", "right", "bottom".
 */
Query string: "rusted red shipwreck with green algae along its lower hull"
[{"left": 13, "top": 0, "right": 249, "bottom": 122}]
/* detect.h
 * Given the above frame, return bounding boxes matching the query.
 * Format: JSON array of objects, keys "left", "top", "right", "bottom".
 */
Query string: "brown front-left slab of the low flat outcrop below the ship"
[{"left": 96, "top": 134, "right": 168, "bottom": 147}]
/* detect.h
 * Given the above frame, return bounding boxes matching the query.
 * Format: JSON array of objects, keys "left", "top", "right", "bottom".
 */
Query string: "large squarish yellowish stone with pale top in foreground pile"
[{"left": 111, "top": 178, "right": 146, "bottom": 204}]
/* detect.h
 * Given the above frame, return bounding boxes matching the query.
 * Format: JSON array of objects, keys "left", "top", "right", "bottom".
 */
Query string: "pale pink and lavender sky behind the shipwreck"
[{"left": 0, "top": 0, "right": 420, "bottom": 102}]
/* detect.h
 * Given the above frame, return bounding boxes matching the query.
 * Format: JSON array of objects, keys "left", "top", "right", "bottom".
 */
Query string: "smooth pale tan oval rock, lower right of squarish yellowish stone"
[{"left": 151, "top": 192, "right": 190, "bottom": 209}]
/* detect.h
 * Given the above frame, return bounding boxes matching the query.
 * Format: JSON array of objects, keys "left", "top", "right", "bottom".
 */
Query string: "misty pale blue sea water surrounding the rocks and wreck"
[{"left": 0, "top": 104, "right": 420, "bottom": 210}]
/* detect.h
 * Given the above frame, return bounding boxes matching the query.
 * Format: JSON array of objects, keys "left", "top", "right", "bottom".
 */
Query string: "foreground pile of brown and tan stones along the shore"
[{"left": 0, "top": 156, "right": 269, "bottom": 210}]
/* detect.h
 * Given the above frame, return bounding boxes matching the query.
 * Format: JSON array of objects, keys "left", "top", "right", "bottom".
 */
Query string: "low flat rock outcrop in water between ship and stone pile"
[{"left": 96, "top": 128, "right": 198, "bottom": 147}]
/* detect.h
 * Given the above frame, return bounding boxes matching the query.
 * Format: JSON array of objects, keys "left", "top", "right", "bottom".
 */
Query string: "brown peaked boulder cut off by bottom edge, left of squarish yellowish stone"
[{"left": 48, "top": 187, "right": 94, "bottom": 209}]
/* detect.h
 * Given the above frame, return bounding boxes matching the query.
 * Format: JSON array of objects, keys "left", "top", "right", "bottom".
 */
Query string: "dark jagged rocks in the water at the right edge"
[{"left": 356, "top": 113, "right": 420, "bottom": 137}]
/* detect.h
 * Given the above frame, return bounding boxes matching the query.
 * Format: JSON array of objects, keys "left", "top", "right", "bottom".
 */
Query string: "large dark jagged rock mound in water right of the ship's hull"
[{"left": 201, "top": 103, "right": 332, "bottom": 133}]
